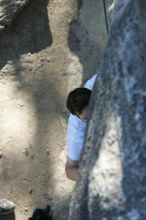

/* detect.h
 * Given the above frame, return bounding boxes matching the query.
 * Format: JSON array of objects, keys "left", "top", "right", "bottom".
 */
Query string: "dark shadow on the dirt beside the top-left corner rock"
[{"left": 0, "top": 0, "right": 53, "bottom": 69}]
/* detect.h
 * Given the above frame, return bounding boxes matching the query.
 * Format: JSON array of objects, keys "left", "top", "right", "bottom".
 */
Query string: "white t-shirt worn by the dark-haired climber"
[{"left": 67, "top": 75, "right": 97, "bottom": 161}]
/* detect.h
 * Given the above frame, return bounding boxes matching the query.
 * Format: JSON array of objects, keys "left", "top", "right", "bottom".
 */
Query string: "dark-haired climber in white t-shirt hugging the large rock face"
[{"left": 65, "top": 74, "right": 97, "bottom": 181}]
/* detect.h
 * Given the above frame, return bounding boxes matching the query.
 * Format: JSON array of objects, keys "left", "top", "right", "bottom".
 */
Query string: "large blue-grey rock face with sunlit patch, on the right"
[{"left": 69, "top": 0, "right": 146, "bottom": 220}]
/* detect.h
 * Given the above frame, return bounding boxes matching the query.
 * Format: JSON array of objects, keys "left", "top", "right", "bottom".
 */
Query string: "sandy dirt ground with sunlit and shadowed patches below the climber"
[{"left": 0, "top": 0, "right": 113, "bottom": 220}]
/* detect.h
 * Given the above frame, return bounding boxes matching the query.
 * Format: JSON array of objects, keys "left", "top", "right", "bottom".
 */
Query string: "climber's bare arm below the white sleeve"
[{"left": 65, "top": 158, "right": 78, "bottom": 181}]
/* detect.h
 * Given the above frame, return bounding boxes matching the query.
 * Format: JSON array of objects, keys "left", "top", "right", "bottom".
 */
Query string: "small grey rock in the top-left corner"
[{"left": 0, "top": 0, "right": 31, "bottom": 32}]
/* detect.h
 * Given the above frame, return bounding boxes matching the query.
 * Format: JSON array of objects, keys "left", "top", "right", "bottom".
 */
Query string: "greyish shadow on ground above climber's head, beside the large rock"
[{"left": 68, "top": 0, "right": 107, "bottom": 82}]
